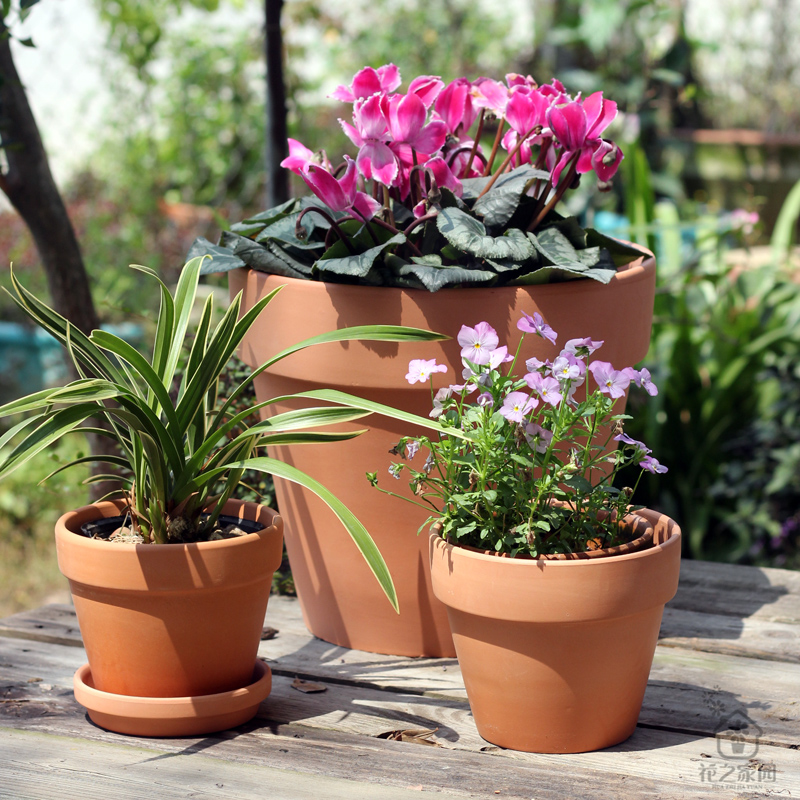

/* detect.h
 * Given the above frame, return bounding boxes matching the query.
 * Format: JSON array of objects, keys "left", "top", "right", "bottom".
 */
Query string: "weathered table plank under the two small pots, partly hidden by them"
[{"left": 0, "top": 639, "right": 800, "bottom": 750}]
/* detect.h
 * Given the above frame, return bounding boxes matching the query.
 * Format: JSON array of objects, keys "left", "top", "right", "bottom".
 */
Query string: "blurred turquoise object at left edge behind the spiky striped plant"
[{"left": 0, "top": 322, "right": 144, "bottom": 403}]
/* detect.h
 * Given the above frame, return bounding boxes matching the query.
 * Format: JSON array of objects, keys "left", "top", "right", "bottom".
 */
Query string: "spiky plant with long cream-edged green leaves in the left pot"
[{"left": 0, "top": 259, "right": 462, "bottom": 606}]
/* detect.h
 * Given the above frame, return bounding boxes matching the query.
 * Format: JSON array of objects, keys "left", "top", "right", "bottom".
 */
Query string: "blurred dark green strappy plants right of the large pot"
[{"left": 631, "top": 222, "right": 800, "bottom": 561}]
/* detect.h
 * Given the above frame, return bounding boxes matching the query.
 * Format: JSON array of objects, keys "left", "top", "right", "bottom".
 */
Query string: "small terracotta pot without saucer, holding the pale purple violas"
[{"left": 429, "top": 510, "right": 681, "bottom": 753}]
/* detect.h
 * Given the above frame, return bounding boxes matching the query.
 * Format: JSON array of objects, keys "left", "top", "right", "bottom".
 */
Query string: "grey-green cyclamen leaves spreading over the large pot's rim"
[{"left": 189, "top": 167, "right": 641, "bottom": 292}]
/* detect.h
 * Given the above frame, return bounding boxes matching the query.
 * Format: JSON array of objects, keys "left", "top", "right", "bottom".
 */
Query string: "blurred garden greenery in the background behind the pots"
[{"left": 0, "top": 0, "right": 800, "bottom": 611}]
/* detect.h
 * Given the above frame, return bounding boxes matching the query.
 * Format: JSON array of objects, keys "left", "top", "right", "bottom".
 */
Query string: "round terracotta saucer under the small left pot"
[{"left": 73, "top": 661, "right": 272, "bottom": 736}]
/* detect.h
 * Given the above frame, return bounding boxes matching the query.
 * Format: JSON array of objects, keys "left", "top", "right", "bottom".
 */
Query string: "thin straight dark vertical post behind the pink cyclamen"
[{"left": 264, "top": 0, "right": 289, "bottom": 208}]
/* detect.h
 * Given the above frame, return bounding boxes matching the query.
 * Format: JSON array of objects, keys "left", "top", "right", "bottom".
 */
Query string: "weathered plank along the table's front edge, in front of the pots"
[{"left": 0, "top": 717, "right": 800, "bottom": 800}]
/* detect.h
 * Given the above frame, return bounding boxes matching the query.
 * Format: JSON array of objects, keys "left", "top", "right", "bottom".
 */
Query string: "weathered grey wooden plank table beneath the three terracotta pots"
[{"left": 0, "top": 562, "right": 800, "bottom": 800}]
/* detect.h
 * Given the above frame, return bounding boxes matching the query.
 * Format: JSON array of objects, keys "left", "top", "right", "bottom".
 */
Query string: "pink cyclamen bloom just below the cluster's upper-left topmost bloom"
[{"left": 339, "top": 94, "right": 400, "bottom": 186}]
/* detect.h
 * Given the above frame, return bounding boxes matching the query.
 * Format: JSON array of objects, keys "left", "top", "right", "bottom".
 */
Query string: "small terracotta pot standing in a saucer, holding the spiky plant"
[{"left": 56, "top": 500, "right": 283, "bottom": 735}]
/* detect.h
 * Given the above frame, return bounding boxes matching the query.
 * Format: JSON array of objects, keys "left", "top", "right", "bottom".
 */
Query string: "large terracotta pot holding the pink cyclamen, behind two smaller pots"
[{"left": 229, "top": 250, "right": 655, "bottom": 656}]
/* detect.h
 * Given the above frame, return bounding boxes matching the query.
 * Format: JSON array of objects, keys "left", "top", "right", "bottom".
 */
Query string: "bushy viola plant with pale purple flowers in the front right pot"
[{"left": 369, "top": 313, "right": 667, "bottom": 556}]
